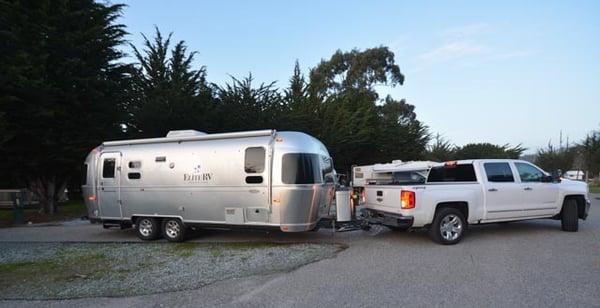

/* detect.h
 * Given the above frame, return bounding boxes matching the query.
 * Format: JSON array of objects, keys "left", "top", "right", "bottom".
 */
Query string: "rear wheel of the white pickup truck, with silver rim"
[{"left": 429, "top": 207, "right": 467, "bottom": 245}]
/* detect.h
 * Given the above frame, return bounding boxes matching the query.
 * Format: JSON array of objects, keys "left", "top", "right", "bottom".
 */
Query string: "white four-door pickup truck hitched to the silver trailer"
[{"left": 362, "top": 159, "right": 590, "bottom": 244}]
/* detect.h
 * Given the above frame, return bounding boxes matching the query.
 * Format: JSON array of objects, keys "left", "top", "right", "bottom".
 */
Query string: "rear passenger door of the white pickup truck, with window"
[{"left": 482, "top": 162, "right": 523, "bottom": 220}]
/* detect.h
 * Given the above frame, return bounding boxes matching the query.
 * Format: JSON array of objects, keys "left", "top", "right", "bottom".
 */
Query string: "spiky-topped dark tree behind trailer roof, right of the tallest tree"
[{"left": 126, "top": 28, "right": 216, "bottom": 137}]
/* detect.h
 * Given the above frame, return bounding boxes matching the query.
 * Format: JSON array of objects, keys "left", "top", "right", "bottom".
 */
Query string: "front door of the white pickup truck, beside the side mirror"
[{"left": 515, "top": 162, "right": 559, "bottom": 216}]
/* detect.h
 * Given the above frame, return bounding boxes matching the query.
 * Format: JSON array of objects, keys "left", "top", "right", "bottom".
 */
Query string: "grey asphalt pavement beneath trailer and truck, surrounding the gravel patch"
[{"left": 0, "top": 195, "right": 600, "bottom": 307}]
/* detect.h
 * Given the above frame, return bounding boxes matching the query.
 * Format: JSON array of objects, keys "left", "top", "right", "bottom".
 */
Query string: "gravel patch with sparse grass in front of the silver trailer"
[{"left": 0, "top": 243, "right": 344, "bottom": 299}]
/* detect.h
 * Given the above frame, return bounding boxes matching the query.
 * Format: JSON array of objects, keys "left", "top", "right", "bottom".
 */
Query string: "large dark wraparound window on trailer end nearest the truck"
[{"left": 281, "top": 153, "right": 323, "bottom": 184}]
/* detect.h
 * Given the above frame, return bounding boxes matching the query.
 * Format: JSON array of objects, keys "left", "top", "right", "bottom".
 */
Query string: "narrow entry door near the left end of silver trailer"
[{"left": 97, "top": 152, "right": 123, "bottom": 219}]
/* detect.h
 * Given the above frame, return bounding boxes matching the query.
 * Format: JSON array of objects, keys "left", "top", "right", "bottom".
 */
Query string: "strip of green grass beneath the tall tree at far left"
[{"left": 0, "top": 200, "right": 87, "bottom": 227}]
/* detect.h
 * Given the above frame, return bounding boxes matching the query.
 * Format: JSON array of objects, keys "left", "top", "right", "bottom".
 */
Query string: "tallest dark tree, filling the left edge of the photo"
[{"left": 0, "top": 0, "right": 129, "bottom": 213}]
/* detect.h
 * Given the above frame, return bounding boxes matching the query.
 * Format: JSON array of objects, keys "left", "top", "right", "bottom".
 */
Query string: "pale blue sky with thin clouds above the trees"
[{"left": 121, "top": 0, "right": 600, "bottom": 152}]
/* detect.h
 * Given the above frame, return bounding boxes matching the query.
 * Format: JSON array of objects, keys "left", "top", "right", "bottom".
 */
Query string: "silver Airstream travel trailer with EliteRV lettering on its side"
[{"left": 82, "top": 130, "right": 335, "bottom": 241}]
